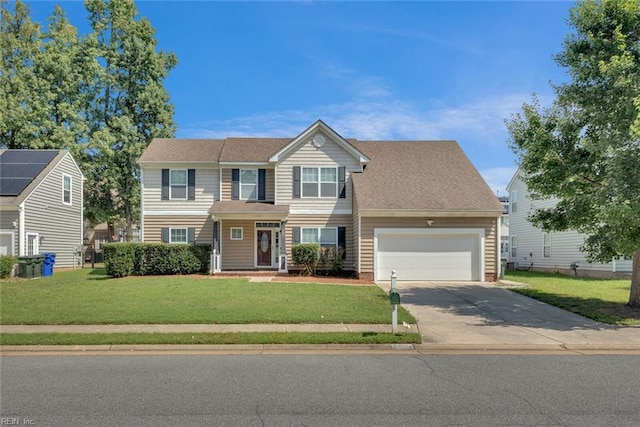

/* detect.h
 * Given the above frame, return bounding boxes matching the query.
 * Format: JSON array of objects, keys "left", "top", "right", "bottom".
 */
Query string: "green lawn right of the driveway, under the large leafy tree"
[{"left": 505, "top": 271, "right": 640, "bottom": 325}]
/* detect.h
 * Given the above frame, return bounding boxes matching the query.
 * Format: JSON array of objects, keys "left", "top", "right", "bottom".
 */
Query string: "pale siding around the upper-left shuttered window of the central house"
[{"left": 142, "top": 163, "right": 220, "bottom": 212}]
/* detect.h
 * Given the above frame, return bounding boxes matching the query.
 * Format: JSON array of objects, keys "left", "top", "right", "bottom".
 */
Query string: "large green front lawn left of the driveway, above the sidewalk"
[{"left": 0, "top": 268, "right": 415, "bottom": 325}]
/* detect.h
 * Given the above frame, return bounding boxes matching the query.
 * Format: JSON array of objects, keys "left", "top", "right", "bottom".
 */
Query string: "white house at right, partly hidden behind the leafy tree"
[{"left": 507, "top": 170, "right": 632, "bottom": 277}]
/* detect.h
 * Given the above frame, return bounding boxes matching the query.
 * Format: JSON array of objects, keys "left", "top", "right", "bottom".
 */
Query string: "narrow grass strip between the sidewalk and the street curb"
[{"left": 0, "top": 332, "right": 422, "bottom": 345}]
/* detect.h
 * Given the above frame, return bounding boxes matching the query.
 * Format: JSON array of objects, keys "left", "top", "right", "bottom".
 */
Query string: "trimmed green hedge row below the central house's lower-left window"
[{"left": 102, "top": 243, "right": 211, "bottom": 277}]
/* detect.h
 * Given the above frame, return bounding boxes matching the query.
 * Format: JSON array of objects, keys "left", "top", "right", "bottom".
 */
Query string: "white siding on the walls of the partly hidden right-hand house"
[{"left": 509, "top": 174, "right": 632, "bottom": 275}]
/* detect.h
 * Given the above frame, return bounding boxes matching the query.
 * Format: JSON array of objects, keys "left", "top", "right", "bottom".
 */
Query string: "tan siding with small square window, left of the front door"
[{"left": 219, "top": 219, "right": 255, "bottom": 270}]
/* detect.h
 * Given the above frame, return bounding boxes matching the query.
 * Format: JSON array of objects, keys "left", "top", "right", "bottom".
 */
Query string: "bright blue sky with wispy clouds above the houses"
[{"left": 28, "top": 1, "right": 574, "bottom": 195}]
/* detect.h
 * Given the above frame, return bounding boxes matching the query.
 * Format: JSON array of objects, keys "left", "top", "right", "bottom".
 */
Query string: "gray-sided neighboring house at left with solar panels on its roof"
[{"left": 0, "top": 150, "right": 84, "bottom": 267}]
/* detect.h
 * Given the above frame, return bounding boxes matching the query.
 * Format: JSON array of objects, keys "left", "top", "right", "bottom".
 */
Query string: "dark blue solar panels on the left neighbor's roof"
[{"left": 0, "top": 150, "right": 58, "bottom": 196}]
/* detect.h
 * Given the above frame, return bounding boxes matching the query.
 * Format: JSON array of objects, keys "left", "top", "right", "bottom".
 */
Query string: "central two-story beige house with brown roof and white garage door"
[{"left": 139, "top": 120, "right": 502, "bottom": 281}]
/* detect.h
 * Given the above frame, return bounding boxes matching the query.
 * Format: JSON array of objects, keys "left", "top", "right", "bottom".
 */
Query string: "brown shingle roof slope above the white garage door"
[{"left": 351, "top": 141, "right": 502, "bottom": 212}]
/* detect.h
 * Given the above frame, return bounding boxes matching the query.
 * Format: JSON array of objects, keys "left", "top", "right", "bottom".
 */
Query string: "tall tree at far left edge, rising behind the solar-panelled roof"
[{"left": 0, "top": 0, "right": 45, "bottom": 148}]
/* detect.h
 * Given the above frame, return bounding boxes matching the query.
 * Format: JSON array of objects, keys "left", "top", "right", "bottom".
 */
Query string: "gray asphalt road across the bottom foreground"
[{"left": 0, "top": 355, "right": 640, "bottom": 427}]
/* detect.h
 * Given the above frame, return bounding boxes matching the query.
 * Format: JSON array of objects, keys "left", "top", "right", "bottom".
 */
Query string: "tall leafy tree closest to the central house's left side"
[{"left": 85, "top": 0, "right": 177, "bottom": 234}]
